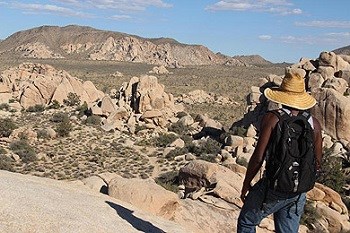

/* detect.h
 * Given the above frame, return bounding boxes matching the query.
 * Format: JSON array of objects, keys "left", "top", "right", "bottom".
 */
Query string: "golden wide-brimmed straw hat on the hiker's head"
[{"left": 264, "top": 72, "right": 316, "bottom": 110}]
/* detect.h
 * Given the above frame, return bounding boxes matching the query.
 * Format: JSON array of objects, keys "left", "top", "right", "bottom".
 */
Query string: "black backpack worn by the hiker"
[{"left": 265, "top": 110, "right": 316, "bottom": 194}]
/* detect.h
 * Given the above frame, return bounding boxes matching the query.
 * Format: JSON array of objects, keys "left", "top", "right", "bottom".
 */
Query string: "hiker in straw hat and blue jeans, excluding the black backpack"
[{"left": 237, "top": 72, "right": 322, "bottom": 233}]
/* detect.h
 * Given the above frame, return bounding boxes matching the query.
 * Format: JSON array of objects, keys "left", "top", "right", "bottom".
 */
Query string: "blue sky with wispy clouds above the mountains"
[{"left": 0, "top": 0, "right": 350, "bottom": 63}]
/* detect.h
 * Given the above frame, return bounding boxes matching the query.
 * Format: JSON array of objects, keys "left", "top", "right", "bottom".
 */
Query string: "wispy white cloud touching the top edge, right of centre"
[{"left": 206, "top": 0, "right": 302, "bottom": 15}]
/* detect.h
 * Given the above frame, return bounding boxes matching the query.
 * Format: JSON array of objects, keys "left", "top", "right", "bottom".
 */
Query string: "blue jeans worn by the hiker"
[{"left": 237, "top": 179, "right": 306, "bottom": 233}]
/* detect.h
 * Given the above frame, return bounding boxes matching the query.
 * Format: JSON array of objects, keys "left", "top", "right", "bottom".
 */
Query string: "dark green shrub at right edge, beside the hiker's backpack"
[{"left": 317, "top": 148, "right": 346, "bottom": 193}]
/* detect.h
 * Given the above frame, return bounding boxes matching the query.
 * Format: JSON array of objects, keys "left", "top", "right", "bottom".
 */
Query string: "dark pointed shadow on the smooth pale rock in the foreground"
[{"left": 106, "top": 201, "right": 165, "bottom": 233}]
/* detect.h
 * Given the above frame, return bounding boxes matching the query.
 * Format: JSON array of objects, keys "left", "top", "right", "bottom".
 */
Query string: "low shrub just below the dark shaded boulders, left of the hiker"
[{"left": 186, "top": 138, "right": 221, "bottom": 156}]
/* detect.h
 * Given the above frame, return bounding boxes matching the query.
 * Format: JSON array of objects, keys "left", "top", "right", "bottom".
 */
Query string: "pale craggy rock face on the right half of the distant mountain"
[{"left": 89, "top": 36, "right": 228, "bottom": 67}]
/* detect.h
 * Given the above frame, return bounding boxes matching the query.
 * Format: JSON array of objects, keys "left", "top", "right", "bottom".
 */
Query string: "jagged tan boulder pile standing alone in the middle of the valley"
[{"left": 91, "top": 75, "right": 182, "bottom": 132}]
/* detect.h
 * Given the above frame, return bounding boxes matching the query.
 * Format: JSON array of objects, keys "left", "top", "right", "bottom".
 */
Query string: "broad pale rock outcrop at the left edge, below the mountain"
[{"left": 0, "top": 63, "right": 104, "bottom": 109}]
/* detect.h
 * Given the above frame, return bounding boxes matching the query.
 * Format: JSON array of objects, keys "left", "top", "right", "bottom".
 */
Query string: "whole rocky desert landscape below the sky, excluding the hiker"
[{"left": 0, "top": 25, "right": 350, "bottom": 233}]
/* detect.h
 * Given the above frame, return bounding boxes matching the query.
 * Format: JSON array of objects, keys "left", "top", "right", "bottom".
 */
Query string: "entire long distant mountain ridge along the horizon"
[{"left": 0, "top": 25, "right": 272, "bottom": 67}]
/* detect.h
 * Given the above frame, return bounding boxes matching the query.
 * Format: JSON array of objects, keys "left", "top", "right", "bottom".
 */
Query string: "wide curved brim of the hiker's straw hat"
[{"left": 264, "top": 88, "right": 316, "bottom": 110}]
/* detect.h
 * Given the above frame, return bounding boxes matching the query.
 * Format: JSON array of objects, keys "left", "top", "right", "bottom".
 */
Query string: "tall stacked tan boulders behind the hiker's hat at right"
[{"left": 245, "top": 52, "right": 350, "bottom": 142}]
